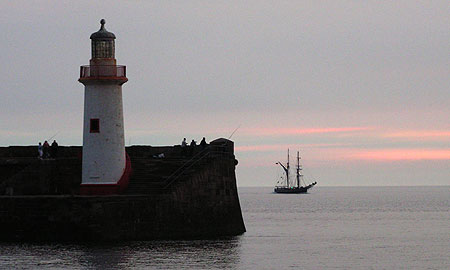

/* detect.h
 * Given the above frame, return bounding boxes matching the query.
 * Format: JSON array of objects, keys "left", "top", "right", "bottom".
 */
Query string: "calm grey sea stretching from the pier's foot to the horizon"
[{"left": 0, "top": 186, "right": 450, "bottom": 270}]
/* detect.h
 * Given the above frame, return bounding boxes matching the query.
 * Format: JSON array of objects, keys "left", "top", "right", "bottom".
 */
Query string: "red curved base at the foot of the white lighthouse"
[{"left": 80, "top": 154, "right": 133, "bottom": 195}]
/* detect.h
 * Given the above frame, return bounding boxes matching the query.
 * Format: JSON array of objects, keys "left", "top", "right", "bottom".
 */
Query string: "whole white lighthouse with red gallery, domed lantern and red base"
[{"left": 79, "top": 19, "right": 131, "bottom": 195}]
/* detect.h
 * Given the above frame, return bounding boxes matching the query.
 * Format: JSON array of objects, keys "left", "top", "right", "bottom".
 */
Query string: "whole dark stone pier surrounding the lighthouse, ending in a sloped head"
[{"left": 0, "top": 139, "right": 245, "bottom": 241}]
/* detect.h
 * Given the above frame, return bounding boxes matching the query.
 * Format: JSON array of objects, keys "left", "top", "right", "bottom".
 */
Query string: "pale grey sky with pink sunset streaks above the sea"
[{"left": 0, "top": 0, "right": 450, "bottom": 186}]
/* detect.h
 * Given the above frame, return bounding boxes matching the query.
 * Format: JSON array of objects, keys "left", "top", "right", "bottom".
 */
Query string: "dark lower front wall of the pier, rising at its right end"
[{"left": 0, "top": 141, "right": 245, "bottom": 242}]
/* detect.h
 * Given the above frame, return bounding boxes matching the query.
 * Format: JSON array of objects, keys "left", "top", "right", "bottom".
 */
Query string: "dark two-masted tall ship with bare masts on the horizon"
[{"left": 273, "top": 149, "right": 317, "bottom": 193}]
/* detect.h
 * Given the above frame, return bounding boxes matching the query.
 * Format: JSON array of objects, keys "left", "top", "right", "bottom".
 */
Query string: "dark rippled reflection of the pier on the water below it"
[{"left": 0, "top": 237, "right": 241, "bottom": 270}]
